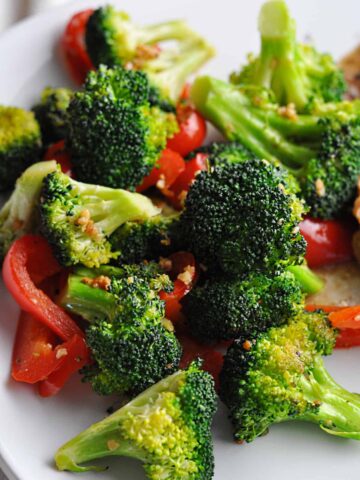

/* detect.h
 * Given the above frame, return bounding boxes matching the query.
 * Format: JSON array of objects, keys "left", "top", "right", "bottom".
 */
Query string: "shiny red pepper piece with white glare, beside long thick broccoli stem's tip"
[{"left": 167, "top": 104, "right": 206, "bottom": 157}]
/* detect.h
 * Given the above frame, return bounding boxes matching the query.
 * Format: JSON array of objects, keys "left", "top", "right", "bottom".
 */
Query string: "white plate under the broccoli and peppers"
[{"left": 0, "top": 0, "right": 360, "bottom": 480}]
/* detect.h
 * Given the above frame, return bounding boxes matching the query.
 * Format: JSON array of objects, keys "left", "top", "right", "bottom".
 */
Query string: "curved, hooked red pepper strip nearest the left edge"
[{"left": 3, "top": 235, "right": 83, "bottom": 340}]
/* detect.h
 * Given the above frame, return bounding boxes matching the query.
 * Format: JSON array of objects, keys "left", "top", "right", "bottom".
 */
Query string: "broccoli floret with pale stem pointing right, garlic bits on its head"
[{"left": 40, "top": 170, "right": 159, "bottom": 268}]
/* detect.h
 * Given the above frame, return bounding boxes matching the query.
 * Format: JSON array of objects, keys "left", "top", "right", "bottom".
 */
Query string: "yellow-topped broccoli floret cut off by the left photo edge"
[{"left": 0, "top": 105, "right": 41, "bottom": 191}]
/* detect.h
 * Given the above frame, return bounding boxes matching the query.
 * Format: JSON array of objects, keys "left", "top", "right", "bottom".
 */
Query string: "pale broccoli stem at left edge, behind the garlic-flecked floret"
[{"left": 0, "top": 161, "right": 56, "bottom": 262}]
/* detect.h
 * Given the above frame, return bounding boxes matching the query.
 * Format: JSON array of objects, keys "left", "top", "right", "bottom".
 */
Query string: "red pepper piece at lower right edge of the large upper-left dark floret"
[{"left": 136, "top": 148, "right": 185, "bottom": 195}]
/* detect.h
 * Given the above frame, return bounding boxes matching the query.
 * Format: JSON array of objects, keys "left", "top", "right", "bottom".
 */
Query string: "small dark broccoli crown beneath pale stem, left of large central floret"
[{"left": 110, "top": 214, "right": 179, "bottom": 263}]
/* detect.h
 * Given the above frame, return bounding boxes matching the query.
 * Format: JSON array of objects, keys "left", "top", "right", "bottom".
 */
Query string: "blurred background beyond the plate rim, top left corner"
[{"left": 0, "top": 0, "right": 69, "bottom": 33}]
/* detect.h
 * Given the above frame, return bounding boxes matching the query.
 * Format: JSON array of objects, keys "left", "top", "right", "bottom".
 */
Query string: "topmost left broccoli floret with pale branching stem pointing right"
[{"left": 86, "top": 6, "right": 214, "bottom": 104}]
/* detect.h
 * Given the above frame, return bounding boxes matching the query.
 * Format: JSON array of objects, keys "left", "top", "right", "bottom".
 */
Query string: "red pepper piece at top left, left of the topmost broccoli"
[{"left": 60, "top": 9, "right": 94, "bottom": 84}]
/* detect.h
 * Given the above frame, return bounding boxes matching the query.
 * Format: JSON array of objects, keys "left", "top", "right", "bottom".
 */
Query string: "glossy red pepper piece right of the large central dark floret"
[{"left": 300, "top": 218, "right": 353, "bottom": 268}]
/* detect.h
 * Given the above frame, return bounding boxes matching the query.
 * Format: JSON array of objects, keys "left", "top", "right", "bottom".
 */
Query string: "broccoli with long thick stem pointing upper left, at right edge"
[{"left": 191, "top": 77, "right": 360, "bottom": 218}]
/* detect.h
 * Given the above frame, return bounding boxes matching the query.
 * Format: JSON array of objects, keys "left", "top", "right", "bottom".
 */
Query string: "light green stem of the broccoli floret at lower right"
[{"left": 298, "top": 358, "right": 360, "bottom": 440}]
